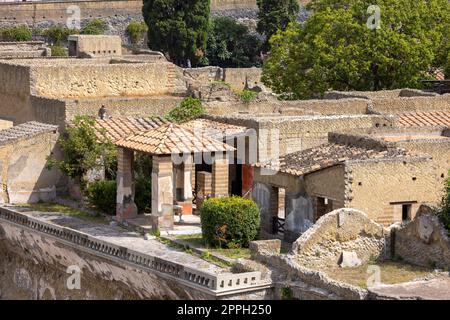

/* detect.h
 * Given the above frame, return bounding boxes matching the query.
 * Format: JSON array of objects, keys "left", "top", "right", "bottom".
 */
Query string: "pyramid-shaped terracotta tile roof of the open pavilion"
[{"left": 116, "top": 123, "right": 235, "bottom": 155}]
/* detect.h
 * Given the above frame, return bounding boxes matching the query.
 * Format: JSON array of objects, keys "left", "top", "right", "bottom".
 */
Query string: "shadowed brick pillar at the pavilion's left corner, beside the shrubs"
[{"left": 116, "top": 148, "right": 137, "bottom": 222}]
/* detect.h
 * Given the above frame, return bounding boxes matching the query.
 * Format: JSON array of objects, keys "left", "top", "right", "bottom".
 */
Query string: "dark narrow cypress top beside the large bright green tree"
[{"left": 257, "top": 0, "right": 300, "bottom": 50}]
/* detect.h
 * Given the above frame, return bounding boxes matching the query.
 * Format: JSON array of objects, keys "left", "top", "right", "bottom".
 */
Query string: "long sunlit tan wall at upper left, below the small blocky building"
[{"left": 30, "top": 59, "right": 186, "bottom": 98}]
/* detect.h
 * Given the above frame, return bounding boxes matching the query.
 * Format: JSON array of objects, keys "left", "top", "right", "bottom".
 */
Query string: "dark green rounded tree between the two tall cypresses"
[{"left": 205, "top": 17, "right": 262, "bottom": 68}]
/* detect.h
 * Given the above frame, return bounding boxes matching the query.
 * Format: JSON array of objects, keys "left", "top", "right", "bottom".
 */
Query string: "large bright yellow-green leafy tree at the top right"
[{"left": 263, "top": 0, "right": 450, "bottom": 99}]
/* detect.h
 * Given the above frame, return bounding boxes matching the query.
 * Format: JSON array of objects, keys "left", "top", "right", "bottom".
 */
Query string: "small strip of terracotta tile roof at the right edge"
[{"left": 398, "top": 111, "right": 450, "bottom": 127}]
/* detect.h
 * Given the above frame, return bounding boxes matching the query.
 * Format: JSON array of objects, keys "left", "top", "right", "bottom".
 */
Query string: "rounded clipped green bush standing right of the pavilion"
[{"left": 201, "top": 197, "right": 260, "bottom": 248}]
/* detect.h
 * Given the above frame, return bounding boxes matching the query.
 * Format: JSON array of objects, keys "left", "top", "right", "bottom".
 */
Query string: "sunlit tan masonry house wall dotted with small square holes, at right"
[{"left": 346, "top": 157, "right": 442, "bottom": 225}]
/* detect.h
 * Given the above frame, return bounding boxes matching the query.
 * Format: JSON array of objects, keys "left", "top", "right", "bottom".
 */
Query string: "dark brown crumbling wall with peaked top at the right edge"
[{"left": 395, "top": 208, "right": 450, "bottom": 270}]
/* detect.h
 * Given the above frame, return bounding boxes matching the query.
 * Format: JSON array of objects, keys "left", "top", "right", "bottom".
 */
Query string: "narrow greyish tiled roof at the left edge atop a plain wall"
[{"left": 0, "top": 121, "right": 58, "bottom": 145}]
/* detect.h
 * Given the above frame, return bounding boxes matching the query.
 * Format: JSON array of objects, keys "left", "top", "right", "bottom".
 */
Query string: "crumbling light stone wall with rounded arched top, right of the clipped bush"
[{"left": 292, "top": 209, "right": 390, "bottom": 267}]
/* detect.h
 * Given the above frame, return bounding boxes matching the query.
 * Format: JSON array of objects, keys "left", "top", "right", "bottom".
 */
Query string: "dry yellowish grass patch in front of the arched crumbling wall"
[{"left": 321, "top": 261, "right": 433, "bottom": 289}]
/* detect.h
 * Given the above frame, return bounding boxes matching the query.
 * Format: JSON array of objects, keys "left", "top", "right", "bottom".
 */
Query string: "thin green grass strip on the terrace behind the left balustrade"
[{"left": 17, "top": 202, "right": 108, "bottom": 224}]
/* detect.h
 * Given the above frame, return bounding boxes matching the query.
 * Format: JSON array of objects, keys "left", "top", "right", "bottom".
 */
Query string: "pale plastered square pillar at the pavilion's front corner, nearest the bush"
[{"left": 152, "top": 156, "right": 174, "bottom": 230}]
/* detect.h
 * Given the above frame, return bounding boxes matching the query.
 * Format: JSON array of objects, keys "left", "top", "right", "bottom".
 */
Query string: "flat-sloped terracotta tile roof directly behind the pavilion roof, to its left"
[{"left": 95, "top": 117, "right": 168, "bottom": 142}]
